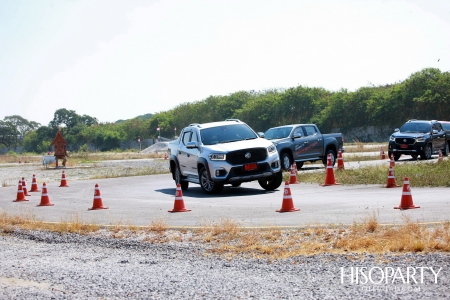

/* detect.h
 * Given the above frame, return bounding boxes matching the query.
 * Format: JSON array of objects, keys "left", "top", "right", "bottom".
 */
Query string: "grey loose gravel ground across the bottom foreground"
[{"left": 0, "top": 230, "right": 450, "bottom": 299}]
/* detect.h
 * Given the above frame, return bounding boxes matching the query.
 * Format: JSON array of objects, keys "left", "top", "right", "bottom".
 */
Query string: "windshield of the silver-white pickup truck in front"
[{"left": 200, "top": 124, "right": 257, "bottom": 145}]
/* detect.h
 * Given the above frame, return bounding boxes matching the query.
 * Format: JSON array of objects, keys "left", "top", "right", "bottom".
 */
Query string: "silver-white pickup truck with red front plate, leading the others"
[{"left": 168, "top": 119, "right": 283, "bottom": 194}]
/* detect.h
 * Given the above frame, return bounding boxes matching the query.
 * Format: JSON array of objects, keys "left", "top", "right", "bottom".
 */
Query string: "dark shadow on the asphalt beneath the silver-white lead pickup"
[{"left": 155, "top": 185, "right": 283, "bottom": 198}]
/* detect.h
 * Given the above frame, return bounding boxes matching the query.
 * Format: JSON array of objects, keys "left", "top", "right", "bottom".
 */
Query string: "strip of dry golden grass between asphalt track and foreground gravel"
[{"left": 0, "top": 212, "right": 450, "bottom": 259}]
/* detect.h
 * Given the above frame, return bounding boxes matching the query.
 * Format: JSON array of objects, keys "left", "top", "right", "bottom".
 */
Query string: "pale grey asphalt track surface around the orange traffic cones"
[{"left": 0, "top": 155, "right": 450, "bottom": 227}]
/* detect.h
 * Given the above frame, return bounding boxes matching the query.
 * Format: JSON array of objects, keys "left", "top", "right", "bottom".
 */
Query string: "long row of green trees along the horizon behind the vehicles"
[{"left": 0, "top": 68, "right": 450, "bottom": 152}]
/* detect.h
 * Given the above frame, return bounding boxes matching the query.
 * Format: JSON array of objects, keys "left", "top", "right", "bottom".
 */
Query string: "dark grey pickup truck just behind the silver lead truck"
[{"left": 262, "top": 124, "right": 344, "bottom": 170}]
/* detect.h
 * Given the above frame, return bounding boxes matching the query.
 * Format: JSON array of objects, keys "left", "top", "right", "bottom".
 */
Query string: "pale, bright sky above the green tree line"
[{"left": 0, "top": 0, "right": 450, "bottom": 125}]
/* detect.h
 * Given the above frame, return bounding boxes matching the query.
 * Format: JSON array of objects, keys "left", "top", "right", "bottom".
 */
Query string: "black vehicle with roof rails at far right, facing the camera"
[{"left": 388, "top": 120, "right": 450, "bottom": 160}]
